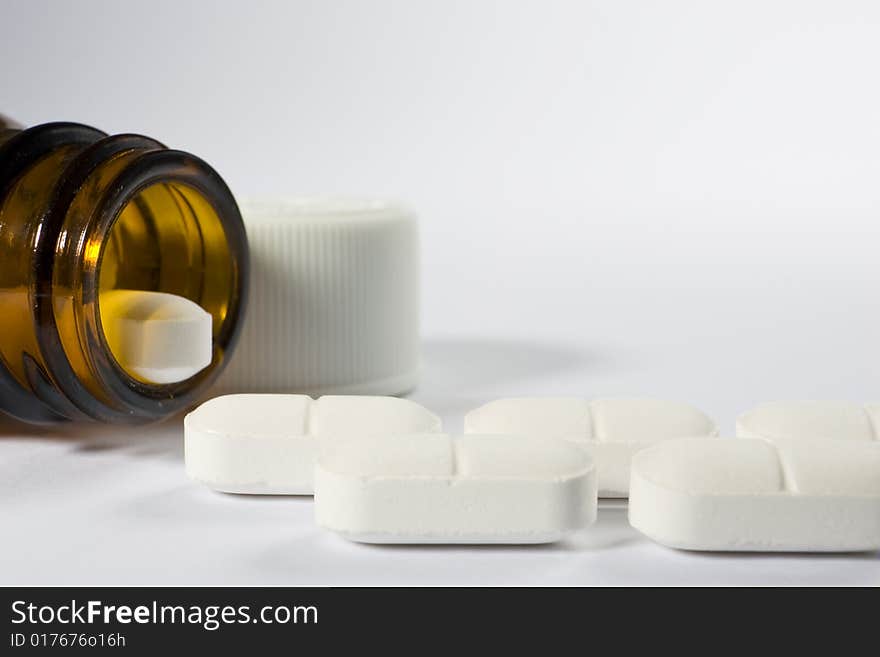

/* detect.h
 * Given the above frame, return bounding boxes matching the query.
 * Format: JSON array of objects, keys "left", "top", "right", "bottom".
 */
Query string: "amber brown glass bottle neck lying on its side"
[{"left": 0, "top": 123, "right": 248, "bottom": 423}]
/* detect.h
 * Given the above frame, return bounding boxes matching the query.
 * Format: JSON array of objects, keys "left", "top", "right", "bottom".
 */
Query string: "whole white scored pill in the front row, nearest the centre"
[{"left": 315, "top": 434, "right": 596, "bottom": 543}]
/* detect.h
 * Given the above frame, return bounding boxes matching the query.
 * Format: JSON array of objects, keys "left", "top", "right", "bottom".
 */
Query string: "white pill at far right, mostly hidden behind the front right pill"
[{"left": 736, "top": 401, "right": 880, "bottom": 440}]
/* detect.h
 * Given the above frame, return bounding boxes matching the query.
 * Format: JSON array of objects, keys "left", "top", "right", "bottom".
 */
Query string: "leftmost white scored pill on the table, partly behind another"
[{"left": 184, "top": 394, "right": 441, "bottom": 495}]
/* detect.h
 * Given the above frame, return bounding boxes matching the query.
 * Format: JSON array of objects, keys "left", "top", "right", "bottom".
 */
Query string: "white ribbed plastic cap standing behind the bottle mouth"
[{"left": 218, "top": 199, "right": 419, "bottom": 396}]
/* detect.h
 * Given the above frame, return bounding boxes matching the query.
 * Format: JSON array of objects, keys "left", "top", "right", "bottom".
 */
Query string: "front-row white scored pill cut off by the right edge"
[{"left": 629, "top": 438, "right": 880, "bottom": 552}]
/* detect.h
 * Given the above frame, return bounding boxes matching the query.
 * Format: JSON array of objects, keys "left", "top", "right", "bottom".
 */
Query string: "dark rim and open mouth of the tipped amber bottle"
[{"left": 84, "top": 150, "right": 248, "bottom": 417}]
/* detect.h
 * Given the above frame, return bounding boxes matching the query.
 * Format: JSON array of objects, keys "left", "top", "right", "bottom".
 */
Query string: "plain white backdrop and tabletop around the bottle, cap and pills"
[{"left": 0, "top": 0, "right": 880, "bottom": 584}]
